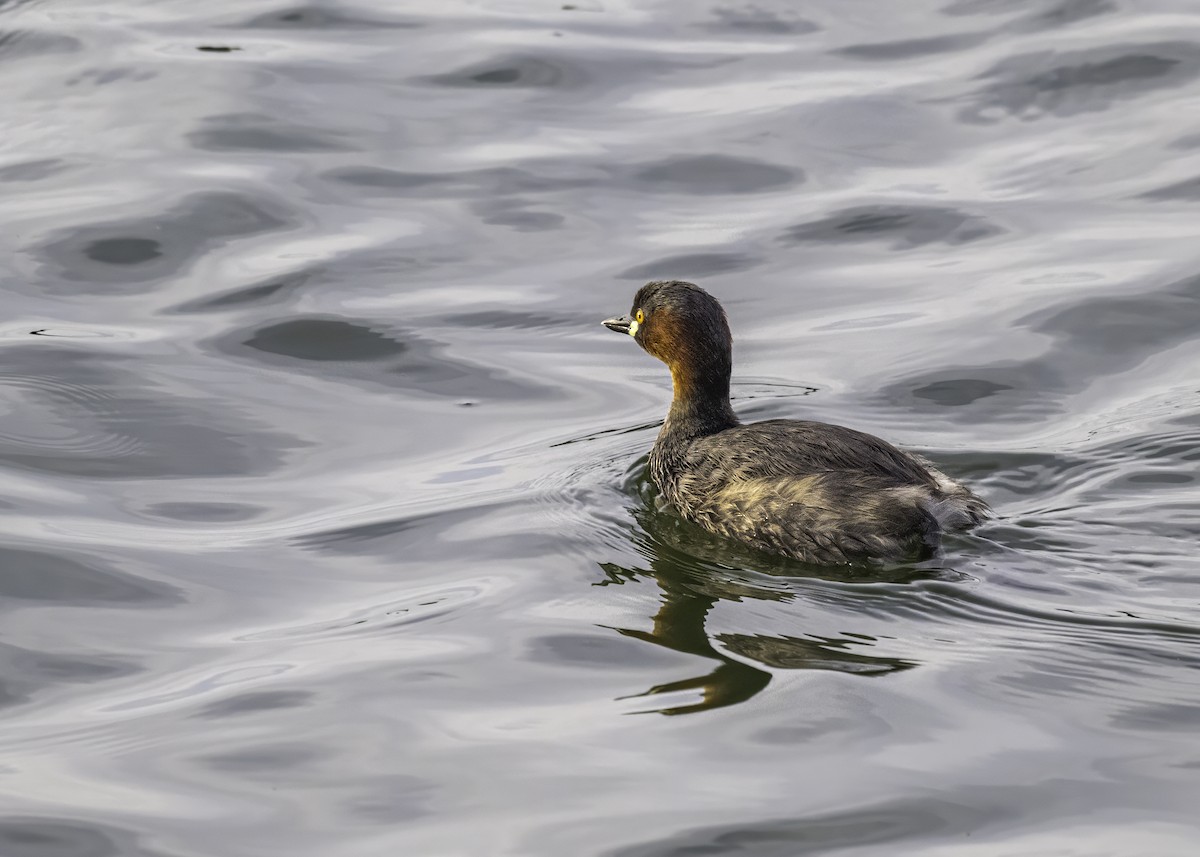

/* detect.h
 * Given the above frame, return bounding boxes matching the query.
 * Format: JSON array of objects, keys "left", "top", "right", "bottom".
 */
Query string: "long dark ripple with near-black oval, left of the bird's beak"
[{"left": 225, "top": 316, "right": 544, "bottom": 401}]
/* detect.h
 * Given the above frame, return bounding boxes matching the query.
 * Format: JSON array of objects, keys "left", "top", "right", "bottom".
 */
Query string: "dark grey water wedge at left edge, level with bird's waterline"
[{"left": 0, "top": 547, "right": 182, "bottom": 606}]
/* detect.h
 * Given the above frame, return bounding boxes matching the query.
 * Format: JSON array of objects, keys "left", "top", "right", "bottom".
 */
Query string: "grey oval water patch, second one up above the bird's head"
[{"left": 632, "top": 155, "right": 804, "bottom": 196}]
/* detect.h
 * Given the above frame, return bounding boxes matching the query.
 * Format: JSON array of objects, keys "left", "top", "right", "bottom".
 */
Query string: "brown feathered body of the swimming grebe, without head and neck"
[{"left": 650, "top": 420, "right": 988, "bottom": 563}]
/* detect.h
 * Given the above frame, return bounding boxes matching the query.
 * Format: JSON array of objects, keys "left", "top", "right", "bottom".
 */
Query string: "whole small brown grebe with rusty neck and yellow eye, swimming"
[{"left": 604, "top": 280, "right": 989, "bottom": 564}]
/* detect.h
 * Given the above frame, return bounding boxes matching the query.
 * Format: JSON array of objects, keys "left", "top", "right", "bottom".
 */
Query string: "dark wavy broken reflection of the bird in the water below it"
[{"left": 598, "top": 477, "right": 926, "bottom": 714}]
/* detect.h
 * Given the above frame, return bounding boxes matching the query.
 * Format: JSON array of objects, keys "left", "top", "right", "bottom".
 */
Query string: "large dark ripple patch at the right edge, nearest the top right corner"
[{"left": 959, "top": 42, "right": 1200, "bottom": 125}]
